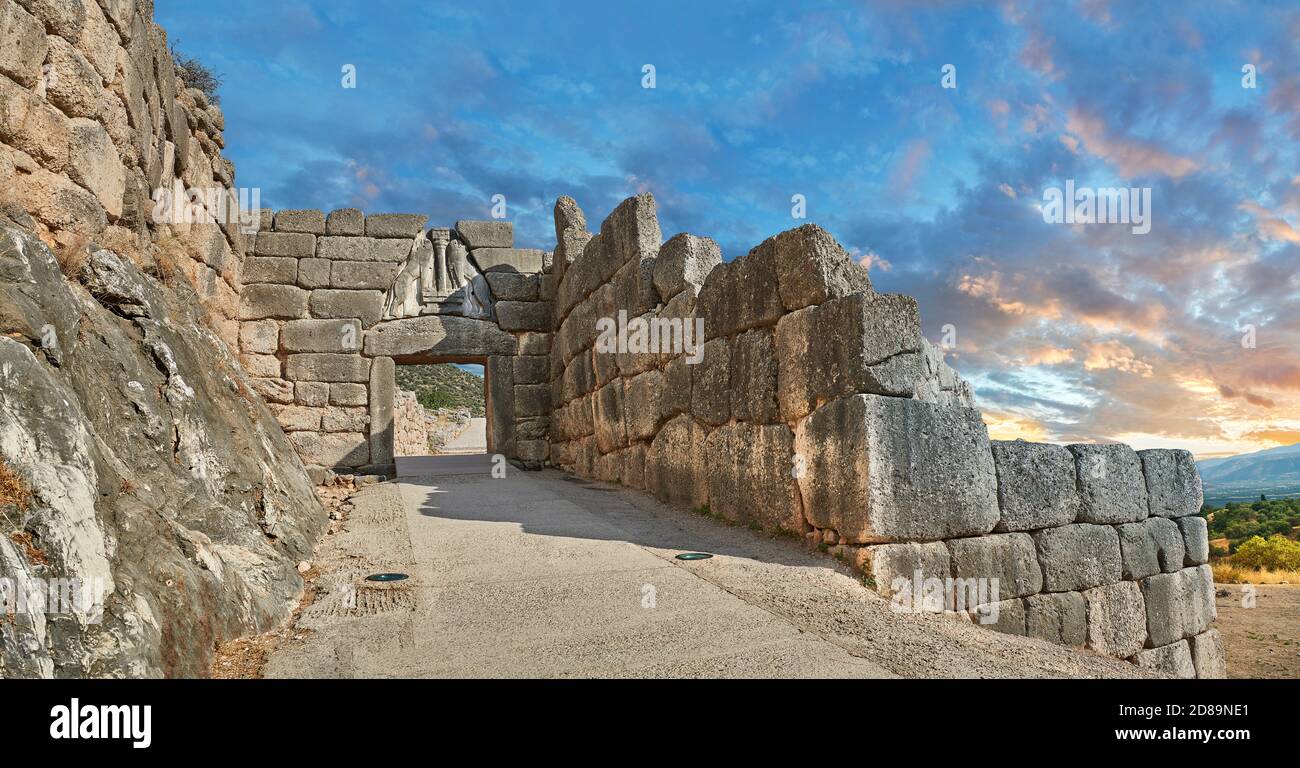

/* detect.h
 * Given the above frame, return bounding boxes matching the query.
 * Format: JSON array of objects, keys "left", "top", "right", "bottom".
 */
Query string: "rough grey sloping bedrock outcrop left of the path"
[{"left": 0, "top": 209, "right": 325, "bottom": 677}]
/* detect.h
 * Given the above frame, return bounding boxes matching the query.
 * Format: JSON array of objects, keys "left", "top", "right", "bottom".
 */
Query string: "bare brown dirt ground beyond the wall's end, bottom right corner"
[{"left": 1214, "top": 583, "right": 1300, "bottom": 680}]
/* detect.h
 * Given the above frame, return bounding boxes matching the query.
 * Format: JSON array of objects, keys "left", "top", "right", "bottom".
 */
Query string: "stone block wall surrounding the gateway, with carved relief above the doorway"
[{"left": 239, "top": 209, "right": 551, "bottom": 480}]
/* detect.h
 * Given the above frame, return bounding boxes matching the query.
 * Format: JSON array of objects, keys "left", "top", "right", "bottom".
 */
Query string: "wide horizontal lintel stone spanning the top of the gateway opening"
[{"left": 365, "top": 314, "right": 519, "bottom": 357}]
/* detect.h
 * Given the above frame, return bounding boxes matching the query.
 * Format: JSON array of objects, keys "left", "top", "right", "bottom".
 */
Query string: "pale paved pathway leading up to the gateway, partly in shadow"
[{"left": 265, "top": 457, "right": 1140, "bottom": 677}]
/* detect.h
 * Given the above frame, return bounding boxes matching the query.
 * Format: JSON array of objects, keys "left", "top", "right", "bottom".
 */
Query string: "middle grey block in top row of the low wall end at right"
[{"left": 1069, "top": 443, "right": 1147, "bottom": 524}]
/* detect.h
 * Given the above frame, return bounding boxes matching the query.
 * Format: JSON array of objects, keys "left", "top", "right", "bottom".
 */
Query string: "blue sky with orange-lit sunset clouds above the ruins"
[{"left": 156, "top": 0, "right": 1300, "bottom": 455}]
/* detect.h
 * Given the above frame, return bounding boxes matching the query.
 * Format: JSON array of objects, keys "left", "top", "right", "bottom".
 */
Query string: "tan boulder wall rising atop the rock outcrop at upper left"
[{"left": 0, "top": 0, "right": 244, "bottom": 350}]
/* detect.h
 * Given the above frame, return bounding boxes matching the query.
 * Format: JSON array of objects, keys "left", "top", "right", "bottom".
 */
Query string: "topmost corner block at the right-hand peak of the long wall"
[{"left": 755, "top": 224, "right": 871, "bottom": 311}]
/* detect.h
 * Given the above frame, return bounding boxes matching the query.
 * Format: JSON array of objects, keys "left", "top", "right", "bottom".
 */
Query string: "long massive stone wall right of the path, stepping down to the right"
[{"left": 549, "top": 195, "right": 1225, "bottom": 677}]
